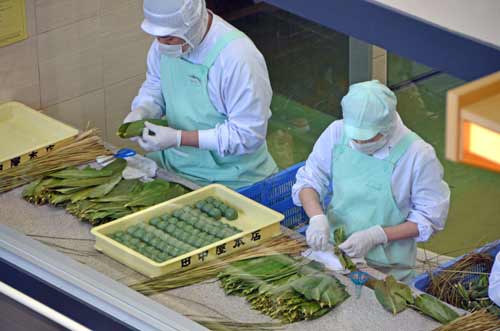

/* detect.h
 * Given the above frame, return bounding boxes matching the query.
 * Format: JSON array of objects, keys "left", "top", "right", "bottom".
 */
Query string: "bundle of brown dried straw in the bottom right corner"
[{"left": 434, "top": 308, "right": 500, "bottom": 331}]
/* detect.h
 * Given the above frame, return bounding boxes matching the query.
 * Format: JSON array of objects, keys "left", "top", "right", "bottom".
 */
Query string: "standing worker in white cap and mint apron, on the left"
[{"left": 124, "top": 0, "right": 278, "bottom": 189}]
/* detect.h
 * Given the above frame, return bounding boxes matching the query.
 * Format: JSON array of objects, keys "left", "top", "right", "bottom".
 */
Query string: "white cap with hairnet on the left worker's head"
[{"left": 141, "top": 0, "right": 208, "bottom": 47}]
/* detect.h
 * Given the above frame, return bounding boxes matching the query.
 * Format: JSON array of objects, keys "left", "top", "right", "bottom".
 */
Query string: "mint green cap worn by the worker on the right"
[{"left": 341, "top": 80, "right": 397, "bottom": 140}]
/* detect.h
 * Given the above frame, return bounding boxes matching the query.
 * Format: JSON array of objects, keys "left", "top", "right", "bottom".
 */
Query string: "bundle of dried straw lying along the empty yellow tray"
[{"left": 0, "top": 129, "right": 110, "bottom": 193}]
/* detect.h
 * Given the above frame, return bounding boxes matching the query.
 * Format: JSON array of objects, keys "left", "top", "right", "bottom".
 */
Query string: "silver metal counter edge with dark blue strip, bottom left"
[{"left": 0, "top": 225, "right": 207, "bottom": 331}]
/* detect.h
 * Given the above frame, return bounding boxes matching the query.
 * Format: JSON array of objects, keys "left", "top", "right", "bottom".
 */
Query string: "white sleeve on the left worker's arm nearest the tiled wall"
[{"left": 132, "top": 40, "right": 165, "bottom": 117}]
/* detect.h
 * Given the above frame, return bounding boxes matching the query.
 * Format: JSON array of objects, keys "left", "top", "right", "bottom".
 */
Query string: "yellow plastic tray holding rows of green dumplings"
[{"left": 92, "top": 184, "right": 284, "bottom": 277}]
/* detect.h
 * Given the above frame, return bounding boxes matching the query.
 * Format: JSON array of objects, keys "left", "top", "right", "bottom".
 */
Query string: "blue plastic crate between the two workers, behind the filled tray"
[{"left": 238, "top": 162, "right": 308, "bottom": 228}]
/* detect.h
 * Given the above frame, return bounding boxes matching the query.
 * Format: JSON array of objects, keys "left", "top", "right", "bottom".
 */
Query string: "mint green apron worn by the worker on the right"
[{"left": 328, "top": 132, "right": 419, "bottom": 280}]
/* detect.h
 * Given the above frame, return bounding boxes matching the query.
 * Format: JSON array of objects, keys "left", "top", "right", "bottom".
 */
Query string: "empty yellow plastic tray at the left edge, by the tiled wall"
[{"left": 0, "top": 102, "right": 78, "bottom": 171}]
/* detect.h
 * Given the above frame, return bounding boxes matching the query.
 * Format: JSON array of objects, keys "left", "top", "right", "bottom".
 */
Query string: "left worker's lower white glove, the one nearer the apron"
[{"left": 138, "top": 122, "right": 182, "bottom": 152}]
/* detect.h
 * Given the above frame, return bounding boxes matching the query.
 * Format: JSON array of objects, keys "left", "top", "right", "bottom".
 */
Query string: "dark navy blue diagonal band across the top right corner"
[{"left": 265, "top": 0, "right": 500, "bottom": 81}]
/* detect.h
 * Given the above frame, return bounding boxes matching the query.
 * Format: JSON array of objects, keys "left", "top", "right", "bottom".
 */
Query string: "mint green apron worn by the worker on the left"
[{"left": 147, "top": 30, "right": 278, "bottom": 189}]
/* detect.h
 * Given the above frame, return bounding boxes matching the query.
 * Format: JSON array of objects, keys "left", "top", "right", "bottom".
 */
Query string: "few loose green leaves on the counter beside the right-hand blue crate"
[{"left": 374, "top": 276, "right": 459, "bottom": 324}]
